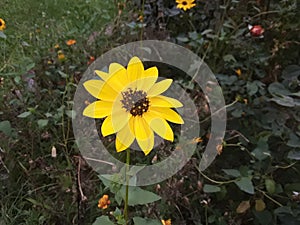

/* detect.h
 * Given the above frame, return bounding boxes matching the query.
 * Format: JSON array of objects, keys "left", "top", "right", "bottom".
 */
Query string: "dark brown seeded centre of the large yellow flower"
[{"left": 121, "top": 88, "right": 150, "bottom": 116}]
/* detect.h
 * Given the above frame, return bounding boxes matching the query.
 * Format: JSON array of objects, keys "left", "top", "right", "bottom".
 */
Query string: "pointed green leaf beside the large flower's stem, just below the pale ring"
[{"left": 119, "top": 186, "right": 161, "bottom": 206}]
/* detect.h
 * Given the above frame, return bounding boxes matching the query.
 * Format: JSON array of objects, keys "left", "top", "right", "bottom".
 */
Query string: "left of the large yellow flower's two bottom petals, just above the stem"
[{"left": 116, "top": 117, "right": 135, "bottom": 152}]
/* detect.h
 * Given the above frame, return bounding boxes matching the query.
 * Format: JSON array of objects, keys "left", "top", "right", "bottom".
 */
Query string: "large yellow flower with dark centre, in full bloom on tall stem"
[{"left": 83, "top": 57, "right": 183, "bottom": 155}]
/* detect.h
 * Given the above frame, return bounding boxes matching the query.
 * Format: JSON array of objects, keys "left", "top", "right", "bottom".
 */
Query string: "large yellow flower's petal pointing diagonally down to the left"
[{"left": 101, "top": 110, "right": 130, "bottom": 137}]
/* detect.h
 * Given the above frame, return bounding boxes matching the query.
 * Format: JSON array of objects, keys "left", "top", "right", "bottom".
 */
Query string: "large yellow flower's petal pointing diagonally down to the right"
[{"left": 143, "top": 112, "right": 174, "bottom": 141}]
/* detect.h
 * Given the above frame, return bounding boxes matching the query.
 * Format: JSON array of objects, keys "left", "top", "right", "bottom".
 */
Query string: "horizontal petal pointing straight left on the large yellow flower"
[{"left": 83, "top": 101, "right": 113, "bottom": 118}]
